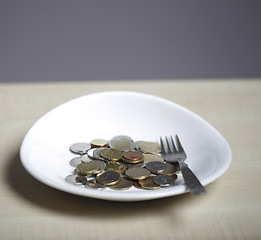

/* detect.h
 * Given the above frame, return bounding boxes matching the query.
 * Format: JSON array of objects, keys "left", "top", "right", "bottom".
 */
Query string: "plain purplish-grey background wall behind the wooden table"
[{"left": 0, "top": 0, "right": 261, "bottom": 82}]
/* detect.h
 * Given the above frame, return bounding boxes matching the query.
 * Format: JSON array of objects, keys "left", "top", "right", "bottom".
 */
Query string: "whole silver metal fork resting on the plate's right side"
[{"left": 160, "top": 135, "right": 206, "bottom": 195}]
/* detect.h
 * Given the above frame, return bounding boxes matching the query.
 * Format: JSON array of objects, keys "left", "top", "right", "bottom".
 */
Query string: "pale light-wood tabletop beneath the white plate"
[{"left": 0, "top": 79, "right": 261, "bottom": 240}]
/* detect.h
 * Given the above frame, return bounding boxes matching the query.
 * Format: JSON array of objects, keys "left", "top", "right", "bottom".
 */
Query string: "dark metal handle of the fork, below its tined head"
[{"left": 179, "top": 161, "right": 206, "bottom": 195}]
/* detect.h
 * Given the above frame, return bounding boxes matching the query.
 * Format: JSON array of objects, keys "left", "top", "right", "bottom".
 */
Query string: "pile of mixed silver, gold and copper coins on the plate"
[{"left": 65, "top": 136, "right": 179, "bottom": 190}]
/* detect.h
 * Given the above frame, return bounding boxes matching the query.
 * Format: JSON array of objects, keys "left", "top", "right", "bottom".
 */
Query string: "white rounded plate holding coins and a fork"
[{"left": 20, "top": 92, "right": 231, "bottom": 201}]
